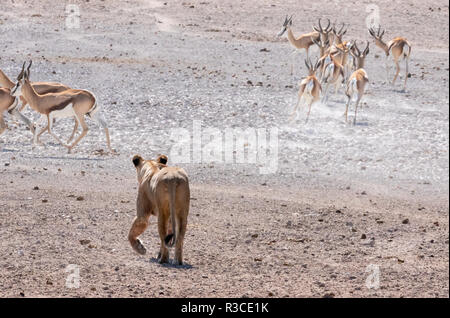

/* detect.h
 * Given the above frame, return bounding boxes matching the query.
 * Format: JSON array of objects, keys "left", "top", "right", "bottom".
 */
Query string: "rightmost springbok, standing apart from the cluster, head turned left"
[{"left": 369, "top": 26, "right": 411, "bottom": 91}]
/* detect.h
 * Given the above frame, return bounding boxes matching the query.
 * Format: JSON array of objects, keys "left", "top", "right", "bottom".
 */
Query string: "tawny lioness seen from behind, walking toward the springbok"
[{"left": 128, "top": 155, "right": 190, "bottom": 265}]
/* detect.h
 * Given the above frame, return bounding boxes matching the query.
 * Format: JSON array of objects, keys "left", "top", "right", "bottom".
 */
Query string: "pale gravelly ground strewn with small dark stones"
[{"left": 0, "top": 0, "right": 449, "bottom": 297}]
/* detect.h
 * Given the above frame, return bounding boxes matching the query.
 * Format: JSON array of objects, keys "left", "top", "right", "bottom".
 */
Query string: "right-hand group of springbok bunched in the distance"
[{"left": 278, "top": 16, "right": 411, "bottom": 124}]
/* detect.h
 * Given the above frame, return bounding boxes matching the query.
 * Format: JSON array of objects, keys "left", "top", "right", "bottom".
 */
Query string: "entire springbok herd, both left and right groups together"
[{"left": 0, "top": 16, "right": 411, "bottom": 153}]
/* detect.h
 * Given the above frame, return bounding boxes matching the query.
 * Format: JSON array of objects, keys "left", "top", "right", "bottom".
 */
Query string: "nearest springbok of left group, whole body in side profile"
[{"left": 11, "top": 61, "right": 115, "bottom": 153}]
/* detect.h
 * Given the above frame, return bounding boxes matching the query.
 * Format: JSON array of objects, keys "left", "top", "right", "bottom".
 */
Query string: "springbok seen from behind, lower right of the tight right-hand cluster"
[{"left": 345, "top": 42, "right": 369, "bottom": 124}]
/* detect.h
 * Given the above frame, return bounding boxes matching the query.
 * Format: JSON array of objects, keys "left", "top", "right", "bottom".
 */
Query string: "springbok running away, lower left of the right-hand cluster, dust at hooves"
[{"left": 291, "top": 60, "right": 322, "bottom": 123}]
